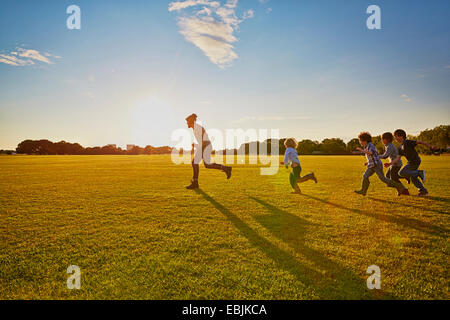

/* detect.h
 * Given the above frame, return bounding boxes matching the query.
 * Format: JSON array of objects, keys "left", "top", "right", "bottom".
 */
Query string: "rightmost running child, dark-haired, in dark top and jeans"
[{"left": 388, "top": 129, "right": 436, "bottom": 196}]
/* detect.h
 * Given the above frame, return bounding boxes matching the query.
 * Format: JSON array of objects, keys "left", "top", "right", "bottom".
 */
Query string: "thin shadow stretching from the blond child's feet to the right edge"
[{"left": 303, "top": 194, "right": 449, "bottom": 236}]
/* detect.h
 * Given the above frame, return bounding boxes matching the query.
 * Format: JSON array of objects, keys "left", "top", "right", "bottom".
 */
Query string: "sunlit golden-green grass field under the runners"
[{"left": 0, "top": 156, "right": 450, "bottom": 299}]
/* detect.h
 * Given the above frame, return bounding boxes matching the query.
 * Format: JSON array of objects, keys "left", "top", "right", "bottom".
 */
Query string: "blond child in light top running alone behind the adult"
[{"left": 284, "top": 138, "right": 317, "bottom": 194}]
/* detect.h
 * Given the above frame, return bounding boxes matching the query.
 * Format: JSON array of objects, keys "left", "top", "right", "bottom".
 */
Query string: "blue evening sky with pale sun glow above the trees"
[{"left": 0, "top": 0, "right": 450, "bottom": 149}]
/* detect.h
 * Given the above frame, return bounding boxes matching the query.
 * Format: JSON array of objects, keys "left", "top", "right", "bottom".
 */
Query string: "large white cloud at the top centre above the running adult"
[{"left": 169, "top": 0, "right": 255, "bottom": 68}]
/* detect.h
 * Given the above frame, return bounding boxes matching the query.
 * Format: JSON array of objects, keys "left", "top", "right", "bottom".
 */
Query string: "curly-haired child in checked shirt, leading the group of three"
[{"left": 355, "top": 132, "right": 406, "bottom": 196}]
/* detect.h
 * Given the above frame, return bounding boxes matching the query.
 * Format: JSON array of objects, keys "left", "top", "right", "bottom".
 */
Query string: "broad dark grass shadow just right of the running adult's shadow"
[{"left": 250, "top": 197, "right": 393, "bottom": 299}]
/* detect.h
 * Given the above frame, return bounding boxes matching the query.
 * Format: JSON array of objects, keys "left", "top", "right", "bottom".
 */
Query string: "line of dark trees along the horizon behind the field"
[{"left": 16, "top": 125, "right": 450, "bottom": 155}]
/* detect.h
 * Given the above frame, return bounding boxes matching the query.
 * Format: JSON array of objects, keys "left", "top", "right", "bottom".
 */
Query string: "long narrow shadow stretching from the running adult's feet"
[{"left": 196, "top": 189, "right": 378, "bottom": 299}]
